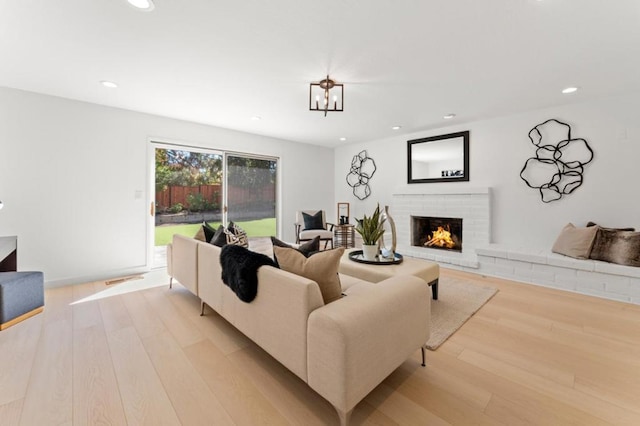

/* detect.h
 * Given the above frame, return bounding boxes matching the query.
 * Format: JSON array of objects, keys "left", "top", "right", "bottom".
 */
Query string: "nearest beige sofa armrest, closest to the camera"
[{"left": 307, "top": 276, "right": 431, "bottom": 412}]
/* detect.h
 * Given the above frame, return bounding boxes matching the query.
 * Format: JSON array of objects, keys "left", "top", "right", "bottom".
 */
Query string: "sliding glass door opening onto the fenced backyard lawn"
[{"left": 149, "top": 143, "right": 278, "bottom": 267}]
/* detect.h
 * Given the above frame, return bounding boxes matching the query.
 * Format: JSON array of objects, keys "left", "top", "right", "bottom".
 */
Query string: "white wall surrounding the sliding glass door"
[{"left": 0, "top": 88, "right": 335, "bottom": 284}]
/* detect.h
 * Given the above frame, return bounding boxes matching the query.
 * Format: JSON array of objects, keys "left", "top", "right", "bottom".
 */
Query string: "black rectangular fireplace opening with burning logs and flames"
[{"left": 411, "top": 216, "right": 462, "bottom": 252}]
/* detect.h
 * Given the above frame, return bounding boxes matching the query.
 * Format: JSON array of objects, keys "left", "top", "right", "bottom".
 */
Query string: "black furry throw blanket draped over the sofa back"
[{"left": 220, "top": 244, "right": 276, "bottom": 303}]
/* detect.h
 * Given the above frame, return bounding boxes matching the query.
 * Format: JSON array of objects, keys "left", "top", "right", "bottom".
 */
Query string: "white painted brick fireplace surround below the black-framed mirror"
[{"left": 390, "top": 185, "right": 491, "bottom": 268}]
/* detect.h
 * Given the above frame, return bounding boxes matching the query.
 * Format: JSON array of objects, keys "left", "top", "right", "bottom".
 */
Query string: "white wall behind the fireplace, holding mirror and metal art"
[{"left": 335, "top": 95, "right": 640, "bottom": 249}]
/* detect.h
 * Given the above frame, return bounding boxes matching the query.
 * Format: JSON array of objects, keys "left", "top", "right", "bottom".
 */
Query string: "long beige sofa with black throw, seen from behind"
[{"left": 167, "top": 235, "right": 430, "bottom": 425}]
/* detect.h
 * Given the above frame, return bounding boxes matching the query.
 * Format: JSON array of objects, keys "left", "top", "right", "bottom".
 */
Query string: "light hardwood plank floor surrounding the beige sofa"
[{"left": 0, "top": 269, "right": 640, "bottom": 426}]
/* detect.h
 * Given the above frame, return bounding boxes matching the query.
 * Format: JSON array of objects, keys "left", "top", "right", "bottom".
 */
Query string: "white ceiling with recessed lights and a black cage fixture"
[{"left": 0, "top": 0, "right": 640, "bottom": 146}]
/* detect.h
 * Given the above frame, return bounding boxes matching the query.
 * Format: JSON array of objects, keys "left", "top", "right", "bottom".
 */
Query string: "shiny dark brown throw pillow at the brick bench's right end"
[{"left": 589, "top": 228, "right": 640, "bottom": 266}]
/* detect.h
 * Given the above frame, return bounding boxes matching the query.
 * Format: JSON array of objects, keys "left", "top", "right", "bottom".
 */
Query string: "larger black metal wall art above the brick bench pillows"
[{"left": 520, "top": 118, "right": 593, "bottom": 203}]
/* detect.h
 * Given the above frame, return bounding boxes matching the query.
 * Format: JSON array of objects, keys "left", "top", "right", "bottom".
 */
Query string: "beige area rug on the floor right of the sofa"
[{"left": 427, "top": 278, "right": 498, "bottom": 351}]
